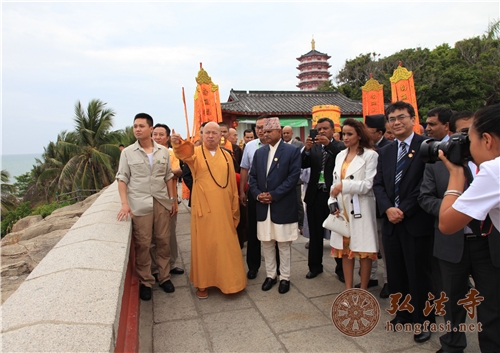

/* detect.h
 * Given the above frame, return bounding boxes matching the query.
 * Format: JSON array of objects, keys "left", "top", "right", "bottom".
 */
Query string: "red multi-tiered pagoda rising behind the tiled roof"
[{"left": 297, "top": 39, "right": 331, "bottom": 91}]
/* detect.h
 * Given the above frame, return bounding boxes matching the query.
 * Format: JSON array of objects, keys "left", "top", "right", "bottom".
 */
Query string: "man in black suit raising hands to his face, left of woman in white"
[{"left": 302, "top": 118, "right": 345, "bottom": 282}]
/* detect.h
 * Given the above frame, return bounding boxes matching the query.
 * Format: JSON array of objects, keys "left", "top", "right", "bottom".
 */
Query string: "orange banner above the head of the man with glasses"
[{"left": 390, "top": 61, "right": 420, "bottom": 134}]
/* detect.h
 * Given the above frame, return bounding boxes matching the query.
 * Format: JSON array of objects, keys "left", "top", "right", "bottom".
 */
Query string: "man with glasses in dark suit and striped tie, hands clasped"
[{"left": 373, "top": 102, "right": 434, "bottom": 343}]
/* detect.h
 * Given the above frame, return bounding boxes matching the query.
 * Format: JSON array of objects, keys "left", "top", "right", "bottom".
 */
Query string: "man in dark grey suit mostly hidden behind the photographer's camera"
[{"left": 418, "top": 111, "right": 482, "bottom": 352}]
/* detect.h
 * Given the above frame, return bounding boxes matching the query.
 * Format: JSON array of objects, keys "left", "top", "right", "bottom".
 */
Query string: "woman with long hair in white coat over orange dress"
[{"left": 328, "top": 119, "right": 378, "bottom": 290}]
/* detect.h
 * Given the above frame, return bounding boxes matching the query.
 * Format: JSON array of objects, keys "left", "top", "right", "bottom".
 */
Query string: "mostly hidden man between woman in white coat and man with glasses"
[{"left": 364, "top": 114, "right": 391, "bottom": 298}]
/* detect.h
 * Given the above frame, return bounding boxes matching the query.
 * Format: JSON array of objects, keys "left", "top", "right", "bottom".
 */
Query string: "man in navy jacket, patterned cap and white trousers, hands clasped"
[{"left": 249, "top": 118, "right": 301, "bottom": 294}]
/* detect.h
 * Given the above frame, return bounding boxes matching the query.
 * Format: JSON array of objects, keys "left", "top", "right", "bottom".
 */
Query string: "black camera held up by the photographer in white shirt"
[{"left": 420, "top": 132, "right": 472, "bottom": 165}]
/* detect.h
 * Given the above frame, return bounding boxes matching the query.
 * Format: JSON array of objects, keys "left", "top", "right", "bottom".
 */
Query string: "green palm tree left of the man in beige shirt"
[{"left": 56, "top": 99, "right": 120, "bottom": 191}]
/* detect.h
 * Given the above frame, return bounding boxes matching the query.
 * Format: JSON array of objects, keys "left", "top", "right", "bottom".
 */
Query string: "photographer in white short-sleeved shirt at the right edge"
[{"left": 439, "top": 104, "right": 500, "bottom": 352}]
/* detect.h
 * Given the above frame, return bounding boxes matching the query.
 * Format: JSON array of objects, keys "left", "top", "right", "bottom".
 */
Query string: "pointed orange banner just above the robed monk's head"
[{"left": 192, "top": 63, "right": 222, "bottom": 141}]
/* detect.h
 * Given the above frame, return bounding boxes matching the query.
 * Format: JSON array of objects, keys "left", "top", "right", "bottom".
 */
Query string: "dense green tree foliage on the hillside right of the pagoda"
[{"left": 336, "top": 21, "right": 500, "bottom": 117}]
